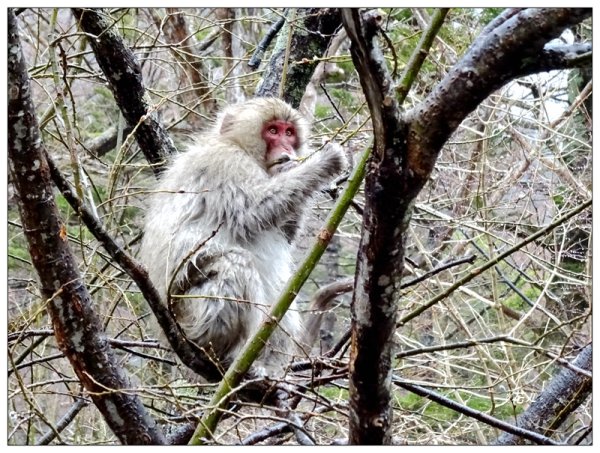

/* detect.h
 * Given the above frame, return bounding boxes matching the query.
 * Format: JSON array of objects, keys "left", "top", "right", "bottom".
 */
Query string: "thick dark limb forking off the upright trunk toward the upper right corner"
[{"left": 407, "top": 8, "right": 591, "bottom": 188}]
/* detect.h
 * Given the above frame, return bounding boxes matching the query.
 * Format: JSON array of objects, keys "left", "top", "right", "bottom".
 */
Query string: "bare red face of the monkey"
[{"left": 262, "top": 120, "right": 299, "bottom": 174}]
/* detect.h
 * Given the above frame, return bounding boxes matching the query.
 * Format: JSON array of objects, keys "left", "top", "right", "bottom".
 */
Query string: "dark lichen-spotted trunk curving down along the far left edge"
[{"left": 8, "top": 11, "right": 165, "bottom": 444}]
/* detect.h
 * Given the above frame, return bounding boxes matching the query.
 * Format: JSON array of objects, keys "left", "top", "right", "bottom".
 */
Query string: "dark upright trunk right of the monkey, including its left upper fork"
[{"left": 342, "top": 9, "right": 412, "bottom": 445}]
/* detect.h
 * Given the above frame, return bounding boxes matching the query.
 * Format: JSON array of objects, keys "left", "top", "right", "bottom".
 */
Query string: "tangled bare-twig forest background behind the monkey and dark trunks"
[{"left": 8, "top": 8, "right": 592, "bottom": 445}]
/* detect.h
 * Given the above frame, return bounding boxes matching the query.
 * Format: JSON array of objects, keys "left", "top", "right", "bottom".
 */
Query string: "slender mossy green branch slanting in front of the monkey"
[{"left": 190, "top": 148, "right": 371, "bottom": 445}]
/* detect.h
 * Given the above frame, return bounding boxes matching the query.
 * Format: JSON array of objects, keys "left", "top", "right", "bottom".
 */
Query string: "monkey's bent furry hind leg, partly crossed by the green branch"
[{"left": 174, "top": 249, "right": 302, "bottom": 378}]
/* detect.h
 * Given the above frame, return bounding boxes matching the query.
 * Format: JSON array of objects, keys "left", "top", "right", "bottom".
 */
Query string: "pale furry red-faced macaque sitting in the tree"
[{"left": 140, "top": 98, "right": 345, "bottom": 376}]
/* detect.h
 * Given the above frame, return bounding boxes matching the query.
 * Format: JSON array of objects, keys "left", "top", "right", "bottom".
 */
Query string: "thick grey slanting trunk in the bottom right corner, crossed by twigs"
[{"left": 495, "top": 344, "right": 592, "bottom": 445}]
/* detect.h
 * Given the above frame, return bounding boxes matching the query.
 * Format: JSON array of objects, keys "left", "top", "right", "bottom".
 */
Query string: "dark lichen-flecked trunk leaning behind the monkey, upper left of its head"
[{"left": 73, "top": 8, "right": 177, "bottom": 174}]
